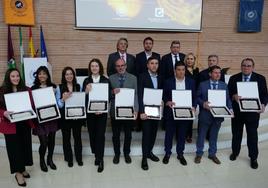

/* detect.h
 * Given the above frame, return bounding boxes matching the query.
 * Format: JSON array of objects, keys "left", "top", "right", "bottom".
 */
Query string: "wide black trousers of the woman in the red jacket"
[{"left": 5, "top": 122, "right": 33, "bottom": 174}]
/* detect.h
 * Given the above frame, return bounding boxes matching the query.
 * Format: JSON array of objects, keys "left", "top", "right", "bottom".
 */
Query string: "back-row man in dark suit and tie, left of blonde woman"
[{"left": 160, "top": 40, "right": 185, "bottom": 79}]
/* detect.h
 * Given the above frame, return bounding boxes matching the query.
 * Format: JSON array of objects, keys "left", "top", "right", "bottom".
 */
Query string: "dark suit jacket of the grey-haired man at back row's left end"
[{"left": 107, "top": 52, "right": 136, "bottom": 76}]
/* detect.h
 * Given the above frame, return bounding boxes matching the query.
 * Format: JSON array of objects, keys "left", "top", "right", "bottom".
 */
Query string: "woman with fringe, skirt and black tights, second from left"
[{"left": 32, "top": 66, "right": 58, "bottom": 172}]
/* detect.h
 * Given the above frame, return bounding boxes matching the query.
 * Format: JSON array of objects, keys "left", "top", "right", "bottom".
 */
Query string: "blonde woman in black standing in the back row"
[{"left": 184, "top": 53, "right": 199, "bottom": 143}]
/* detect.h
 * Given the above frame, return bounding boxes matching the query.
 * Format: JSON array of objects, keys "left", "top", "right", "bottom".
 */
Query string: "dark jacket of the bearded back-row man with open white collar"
[{"left": 135, "top": 51, "right": 160, "bottom": 75}]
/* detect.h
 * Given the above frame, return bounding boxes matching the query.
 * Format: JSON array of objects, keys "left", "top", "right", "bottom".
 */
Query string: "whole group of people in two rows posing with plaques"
[{"left": 0, "top": 37, "right": 268, "bottom": 186}]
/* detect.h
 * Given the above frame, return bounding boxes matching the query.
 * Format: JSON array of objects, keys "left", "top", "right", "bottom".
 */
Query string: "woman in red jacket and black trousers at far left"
[{"left": 0, "top": 69, "right": 34, "bottom": 187}]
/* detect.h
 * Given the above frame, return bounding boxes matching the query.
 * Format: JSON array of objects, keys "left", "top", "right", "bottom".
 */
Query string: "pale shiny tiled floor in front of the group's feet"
[{"left": 0, "top": 141, "right": 268, "bottom": 188}]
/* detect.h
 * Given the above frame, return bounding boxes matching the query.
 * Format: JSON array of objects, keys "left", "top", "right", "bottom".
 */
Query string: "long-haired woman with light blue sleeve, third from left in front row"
[{"left": 56, "top": 67, "right": 84, "bottom": 167}]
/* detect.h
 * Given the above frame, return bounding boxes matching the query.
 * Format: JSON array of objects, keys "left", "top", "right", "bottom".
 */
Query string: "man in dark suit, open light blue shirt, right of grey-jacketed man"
[{"left": 138, "top": 56, "right": 163, "bottom": 170}]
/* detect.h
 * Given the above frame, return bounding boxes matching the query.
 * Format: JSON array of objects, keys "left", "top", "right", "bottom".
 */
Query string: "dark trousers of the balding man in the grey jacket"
[{"left": 111, "top": 118, "right": 134, "bottom": 155}]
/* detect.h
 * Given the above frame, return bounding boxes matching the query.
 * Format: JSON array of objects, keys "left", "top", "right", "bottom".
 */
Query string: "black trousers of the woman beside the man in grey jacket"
[{"left": 87, "top": 113, "right": 107, "bottom": 161}]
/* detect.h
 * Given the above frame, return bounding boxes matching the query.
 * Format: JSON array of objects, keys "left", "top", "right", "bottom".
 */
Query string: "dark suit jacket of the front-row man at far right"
[{"left": 228, "top": 72, "right": 268, "bottom": 115}]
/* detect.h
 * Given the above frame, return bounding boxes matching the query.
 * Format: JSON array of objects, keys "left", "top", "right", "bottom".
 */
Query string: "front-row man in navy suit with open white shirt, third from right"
[{"left": 163, "top": 62, "right": 196, "bottom": 165}]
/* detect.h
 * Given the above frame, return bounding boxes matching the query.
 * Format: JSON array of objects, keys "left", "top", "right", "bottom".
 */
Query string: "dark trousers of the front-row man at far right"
[{"left": 232, "top": 113, "right": 260, "bottom": 160}]
